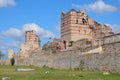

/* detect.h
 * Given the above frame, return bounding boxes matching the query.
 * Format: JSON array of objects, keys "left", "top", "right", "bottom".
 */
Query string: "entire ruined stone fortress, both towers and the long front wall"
[{"left": 14, "top": 10, "right": 120, "bottom": 73}]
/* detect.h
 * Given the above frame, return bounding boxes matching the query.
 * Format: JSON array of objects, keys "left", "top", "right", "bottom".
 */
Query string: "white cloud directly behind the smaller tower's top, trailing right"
[{"left": 23, "top": 23, "right": 55, "bottom": 38}]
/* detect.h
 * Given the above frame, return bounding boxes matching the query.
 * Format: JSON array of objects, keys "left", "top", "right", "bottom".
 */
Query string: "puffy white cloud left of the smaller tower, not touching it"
[{"left": 2, "top": 28, "right": 23, "bottom": 40}]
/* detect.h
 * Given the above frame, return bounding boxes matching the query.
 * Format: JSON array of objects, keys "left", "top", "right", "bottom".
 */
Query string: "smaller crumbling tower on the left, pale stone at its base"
[{"left": 20, "top": 30, "right": 40, "bottom": 58}]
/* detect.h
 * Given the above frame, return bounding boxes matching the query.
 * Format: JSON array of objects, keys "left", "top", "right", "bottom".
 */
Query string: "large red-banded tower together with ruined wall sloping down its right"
[{"left": 61, "top": 9, "right": 113, "bottom": 41}]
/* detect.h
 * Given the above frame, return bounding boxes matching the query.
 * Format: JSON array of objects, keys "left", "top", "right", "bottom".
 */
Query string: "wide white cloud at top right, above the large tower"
[{"left": 72, "top": 0, "right": 118, "bottom": 13}]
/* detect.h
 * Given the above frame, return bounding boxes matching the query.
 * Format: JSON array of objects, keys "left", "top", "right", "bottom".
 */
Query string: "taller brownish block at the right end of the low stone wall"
[{"left": 102, "top": 42, "right": 120, "bottom": 73}]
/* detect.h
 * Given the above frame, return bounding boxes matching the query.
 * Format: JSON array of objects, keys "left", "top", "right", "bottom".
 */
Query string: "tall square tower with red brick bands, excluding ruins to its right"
[{"left": 61, "top": 9, "right": 94, "bottom": 41}]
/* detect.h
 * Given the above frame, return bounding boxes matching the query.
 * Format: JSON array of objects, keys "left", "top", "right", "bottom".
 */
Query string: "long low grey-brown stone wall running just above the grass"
[{"left": 27, "top": 43, "right": 120, "bottom": 73}]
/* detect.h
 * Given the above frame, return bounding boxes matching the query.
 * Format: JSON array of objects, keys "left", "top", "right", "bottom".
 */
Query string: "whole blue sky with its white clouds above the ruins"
[{"left": 0, "top": 0, "right": 120, "bottom": 58}]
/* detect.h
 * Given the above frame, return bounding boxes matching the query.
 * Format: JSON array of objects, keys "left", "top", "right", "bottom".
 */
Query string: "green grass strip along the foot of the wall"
[{"left": 0, "top": 66, "right": 120, "bottom": 80}]
